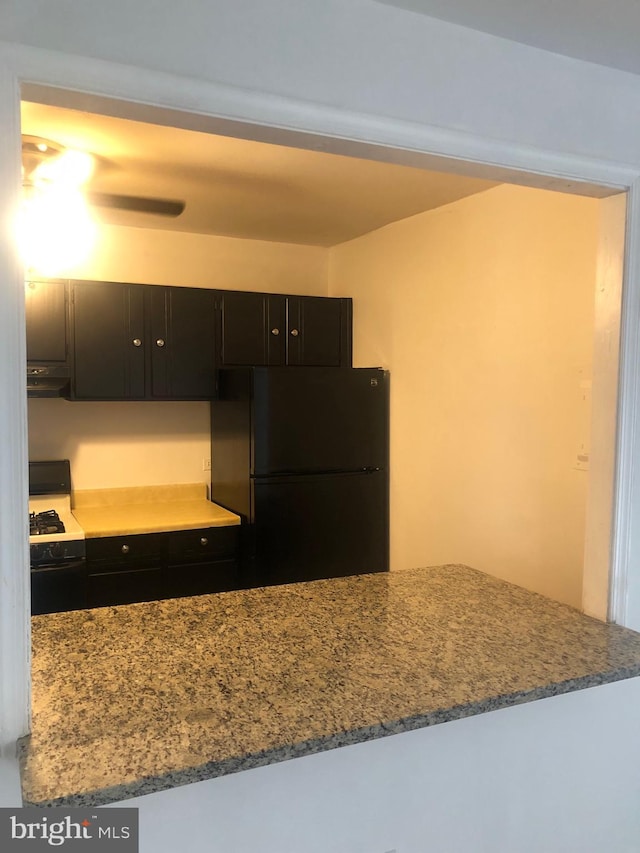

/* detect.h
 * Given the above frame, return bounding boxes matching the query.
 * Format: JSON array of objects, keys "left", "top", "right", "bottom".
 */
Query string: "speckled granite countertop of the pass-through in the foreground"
[{"left": 20, "top": 566, "right": 640, "bottom": 806}]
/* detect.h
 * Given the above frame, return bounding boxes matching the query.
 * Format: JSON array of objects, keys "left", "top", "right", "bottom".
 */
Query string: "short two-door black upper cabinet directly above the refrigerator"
[{"left": 219, "top": 291, "right": 351, "bottom": 367}]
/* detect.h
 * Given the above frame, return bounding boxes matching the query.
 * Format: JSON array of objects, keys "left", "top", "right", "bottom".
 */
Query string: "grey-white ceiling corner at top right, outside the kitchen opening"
[{"left": 378, "top": 0, "right": 640, "bottom": 74}]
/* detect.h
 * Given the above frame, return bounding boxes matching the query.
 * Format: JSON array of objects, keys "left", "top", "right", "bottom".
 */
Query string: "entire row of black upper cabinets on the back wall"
[{"left": 31, "top": 280, "right": 352, "bottom": 400}]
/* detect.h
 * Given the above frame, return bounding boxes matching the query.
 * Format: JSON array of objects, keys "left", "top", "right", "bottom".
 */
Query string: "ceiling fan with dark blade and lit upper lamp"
[{"left": 22, "top": 136, "right": 185, "bottom": 217}]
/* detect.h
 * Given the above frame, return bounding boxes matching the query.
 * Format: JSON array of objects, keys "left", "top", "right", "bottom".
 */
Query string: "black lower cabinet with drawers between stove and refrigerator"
[{"left": 86, "top": 527, "right": 240, "bottom": 607}]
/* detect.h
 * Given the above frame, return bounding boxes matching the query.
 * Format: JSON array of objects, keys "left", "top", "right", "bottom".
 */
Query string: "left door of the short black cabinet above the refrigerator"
[{"left": 220, "top": 291, "right": 286, "bottom": 367}]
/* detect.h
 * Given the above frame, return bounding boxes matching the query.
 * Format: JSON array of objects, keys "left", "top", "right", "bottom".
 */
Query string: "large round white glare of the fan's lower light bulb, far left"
[{"left": 16, "top": 186, "right": 96, "bottom": 276}]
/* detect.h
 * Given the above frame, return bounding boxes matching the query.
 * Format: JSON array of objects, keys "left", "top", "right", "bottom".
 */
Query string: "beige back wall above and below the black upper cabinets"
[{"left": 29, "top": 226, "right": 327, "bottom": 489}]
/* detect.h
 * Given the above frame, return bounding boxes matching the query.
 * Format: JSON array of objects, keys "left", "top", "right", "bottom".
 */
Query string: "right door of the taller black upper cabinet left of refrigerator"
[{"left": 147, "top": 287, "right": 216, "bottom": 400}]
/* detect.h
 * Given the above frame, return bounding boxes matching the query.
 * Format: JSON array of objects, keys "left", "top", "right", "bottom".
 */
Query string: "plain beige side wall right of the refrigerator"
[{"left": 329, "top": 185, "right": 598, "bottom": 607}]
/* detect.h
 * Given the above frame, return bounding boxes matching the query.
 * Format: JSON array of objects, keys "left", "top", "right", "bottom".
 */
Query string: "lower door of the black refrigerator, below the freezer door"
[{"left": 254, "top": 471, "right": 389, "bottom": 585}]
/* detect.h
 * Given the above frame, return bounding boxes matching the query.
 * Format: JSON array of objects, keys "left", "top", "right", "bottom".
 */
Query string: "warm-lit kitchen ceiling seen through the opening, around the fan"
[{"left": 22, "top": 102, "right": 495, "bottom": 246}]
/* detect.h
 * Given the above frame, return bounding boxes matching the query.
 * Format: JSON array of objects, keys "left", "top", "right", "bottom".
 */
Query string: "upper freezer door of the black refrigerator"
[{"left": 253, "top": 367, "right": 389, "bottom": 477}]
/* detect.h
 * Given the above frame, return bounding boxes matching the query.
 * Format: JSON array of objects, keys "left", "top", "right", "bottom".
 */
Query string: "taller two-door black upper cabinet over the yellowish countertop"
[{"left": 72, "top": 282, "right": 216, "bottom": 400}]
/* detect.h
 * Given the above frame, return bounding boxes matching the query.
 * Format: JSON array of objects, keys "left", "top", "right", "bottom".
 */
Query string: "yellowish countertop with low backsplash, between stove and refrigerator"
[{"left": 71, "top": 483, "right": 240, "bottom": 539}]
